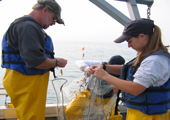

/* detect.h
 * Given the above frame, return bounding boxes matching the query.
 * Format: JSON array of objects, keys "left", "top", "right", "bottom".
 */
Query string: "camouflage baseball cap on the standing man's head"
[{"left": 37, "top": 0, "right": 64, "bottom": 24}]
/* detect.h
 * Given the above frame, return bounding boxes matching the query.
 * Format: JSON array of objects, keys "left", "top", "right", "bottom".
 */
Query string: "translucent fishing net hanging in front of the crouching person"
[{"left": 63, "top": 75, "right": 116, "bottom": 120}]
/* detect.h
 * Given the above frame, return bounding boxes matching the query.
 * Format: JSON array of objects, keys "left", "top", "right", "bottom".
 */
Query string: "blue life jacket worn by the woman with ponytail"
[{"left": 121, "top": 49, "right": 170, "bottom": 115}]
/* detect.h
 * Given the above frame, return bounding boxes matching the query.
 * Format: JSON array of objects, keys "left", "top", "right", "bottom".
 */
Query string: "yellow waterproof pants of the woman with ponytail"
[{"left": 126, "top": 108, "right": 170, "bottom": 120}]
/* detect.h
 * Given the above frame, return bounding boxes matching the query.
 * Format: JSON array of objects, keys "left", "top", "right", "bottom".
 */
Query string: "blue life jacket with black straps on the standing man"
[{"left": 1, "top": 17, "right": 54, "bottom": 75}]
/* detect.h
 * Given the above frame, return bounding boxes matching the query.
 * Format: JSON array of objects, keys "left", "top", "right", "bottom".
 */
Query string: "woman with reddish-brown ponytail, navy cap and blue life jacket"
[{"left": 90, "top": 19, "right": 170, "bottom": 120}]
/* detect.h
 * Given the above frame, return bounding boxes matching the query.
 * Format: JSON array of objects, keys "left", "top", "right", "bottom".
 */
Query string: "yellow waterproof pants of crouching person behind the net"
[{"left": 65, "top": 90, "right": 122, "bottom": 120}]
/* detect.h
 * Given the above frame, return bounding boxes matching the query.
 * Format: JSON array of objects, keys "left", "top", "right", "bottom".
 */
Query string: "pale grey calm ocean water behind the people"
[{"left": 0, "top": 41, "right": 136, "bottom": 105}]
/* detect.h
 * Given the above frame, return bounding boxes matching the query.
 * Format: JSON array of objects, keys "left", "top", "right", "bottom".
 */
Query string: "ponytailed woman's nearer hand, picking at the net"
[{"left": 90, "top": 65, "right": 108, "bottom": 80}]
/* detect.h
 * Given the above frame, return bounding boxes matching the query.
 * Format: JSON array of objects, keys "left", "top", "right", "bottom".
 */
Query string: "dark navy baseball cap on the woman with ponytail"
[{"left": 114, "top": 18, "right": 154, "bottom": 43}]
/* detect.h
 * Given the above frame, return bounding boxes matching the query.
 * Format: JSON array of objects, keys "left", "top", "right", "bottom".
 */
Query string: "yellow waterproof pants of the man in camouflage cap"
[{"left": 3, "top": 69, "right": 49, "bottom": 120}]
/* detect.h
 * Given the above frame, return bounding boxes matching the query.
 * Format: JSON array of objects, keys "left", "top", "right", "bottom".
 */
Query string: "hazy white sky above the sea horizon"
[{"left": 0, "top": 0, "right": 170, "bottom": 45}]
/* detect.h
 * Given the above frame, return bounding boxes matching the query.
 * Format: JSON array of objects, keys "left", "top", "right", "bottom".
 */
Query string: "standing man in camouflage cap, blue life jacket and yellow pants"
[{"left": 1, "top": 0, "right": 67, "bottom": 120}]
